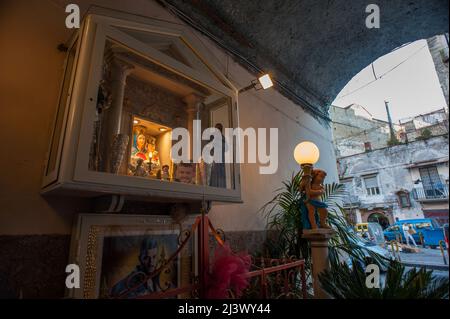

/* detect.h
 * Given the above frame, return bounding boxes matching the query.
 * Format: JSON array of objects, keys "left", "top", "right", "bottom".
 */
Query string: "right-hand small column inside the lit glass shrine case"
[{"left": 183, "top": 93, "right": 204, "bottom": 163}]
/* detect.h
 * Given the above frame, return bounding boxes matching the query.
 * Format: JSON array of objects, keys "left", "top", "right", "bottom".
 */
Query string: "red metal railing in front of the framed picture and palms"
[{"left": 111, "top": 214, "right": 308, "bottom": 299}]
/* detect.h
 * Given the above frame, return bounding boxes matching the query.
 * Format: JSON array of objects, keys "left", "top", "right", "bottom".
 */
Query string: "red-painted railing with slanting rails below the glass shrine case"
[{"left": 118, "top": 213, "right": 307, "bottom": 299}]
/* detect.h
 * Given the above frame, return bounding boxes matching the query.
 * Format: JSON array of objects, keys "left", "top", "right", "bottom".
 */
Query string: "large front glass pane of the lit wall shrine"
[{"left": 89, "top": 40, "right": 235, "bottom": 188}]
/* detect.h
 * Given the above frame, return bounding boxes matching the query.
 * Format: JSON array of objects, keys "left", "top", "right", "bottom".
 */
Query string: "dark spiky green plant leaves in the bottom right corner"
[{"left": 319, "top": 261, "right": 449, "bottom": 299}]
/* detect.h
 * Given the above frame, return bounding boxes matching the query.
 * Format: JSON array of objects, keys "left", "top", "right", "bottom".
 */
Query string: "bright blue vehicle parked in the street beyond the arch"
[{"left": 384, "top": 218, "right": 445, "bottom": 248}]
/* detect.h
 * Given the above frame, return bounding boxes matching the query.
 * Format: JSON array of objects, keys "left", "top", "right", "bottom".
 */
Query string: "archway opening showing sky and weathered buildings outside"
[{"left": 330, "top": 34, "right": 449, "bottom": 227}]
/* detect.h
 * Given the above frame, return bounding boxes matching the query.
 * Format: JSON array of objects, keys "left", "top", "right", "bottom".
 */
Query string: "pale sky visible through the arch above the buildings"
[{"left": 333, "top": 40, "right": 446, "bottom": 123}]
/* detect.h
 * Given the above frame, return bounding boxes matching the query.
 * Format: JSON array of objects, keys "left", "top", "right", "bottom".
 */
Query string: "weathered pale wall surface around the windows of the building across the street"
[{"left": 338, "top": 135, "right": 449, "bottom": 220}]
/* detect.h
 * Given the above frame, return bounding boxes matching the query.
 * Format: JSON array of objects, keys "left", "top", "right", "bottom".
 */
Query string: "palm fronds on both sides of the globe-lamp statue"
[{"left": 262, "top": 172, "right": 387, "bottom": 268}]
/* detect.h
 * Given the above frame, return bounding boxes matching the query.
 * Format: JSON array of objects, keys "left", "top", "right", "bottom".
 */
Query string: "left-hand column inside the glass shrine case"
[{"left": 106, "top": 53, "right": 134, "bottom": 174}]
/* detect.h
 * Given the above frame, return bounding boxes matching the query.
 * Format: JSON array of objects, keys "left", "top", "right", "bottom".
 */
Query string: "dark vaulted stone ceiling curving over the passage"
[{"left": 160, "top": 0, "right": 449, "bottom": 120}]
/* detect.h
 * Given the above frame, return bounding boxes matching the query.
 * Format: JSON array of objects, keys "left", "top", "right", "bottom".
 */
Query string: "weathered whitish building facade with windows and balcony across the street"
[{"left": 338, "top": 135, "right": 448, "bottom": 227}]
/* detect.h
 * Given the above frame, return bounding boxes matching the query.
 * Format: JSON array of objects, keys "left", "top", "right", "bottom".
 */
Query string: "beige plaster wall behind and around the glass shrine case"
[{"left": 0, "top": 0, "right": 337, "bottom": 235}]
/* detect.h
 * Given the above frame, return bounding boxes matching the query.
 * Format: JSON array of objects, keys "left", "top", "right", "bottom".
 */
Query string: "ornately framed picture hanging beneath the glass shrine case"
[{"left": 67, "top": 214, "right": 196, "bottom": 299}]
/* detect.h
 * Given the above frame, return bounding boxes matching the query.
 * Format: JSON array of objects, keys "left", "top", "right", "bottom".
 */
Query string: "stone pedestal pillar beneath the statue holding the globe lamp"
[{"left": 303, "top": 228, "right": 336, "bottom": 299}]
